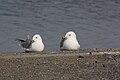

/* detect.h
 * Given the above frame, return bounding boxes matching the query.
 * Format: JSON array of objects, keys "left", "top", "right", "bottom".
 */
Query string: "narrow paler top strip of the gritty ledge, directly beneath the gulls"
[{"left": 0, "top": 48, "right": 120, "bottom": 58}]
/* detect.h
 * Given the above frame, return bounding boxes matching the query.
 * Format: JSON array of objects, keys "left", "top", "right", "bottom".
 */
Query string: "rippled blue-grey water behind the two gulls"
[{"left": 0, "top": 0, "right": 120, "bottom": 52}]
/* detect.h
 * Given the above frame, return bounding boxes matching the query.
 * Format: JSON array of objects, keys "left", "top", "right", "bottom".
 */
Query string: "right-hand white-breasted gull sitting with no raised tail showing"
[{"left": 60, "top": 31, "right": 80, "bottom": 50}]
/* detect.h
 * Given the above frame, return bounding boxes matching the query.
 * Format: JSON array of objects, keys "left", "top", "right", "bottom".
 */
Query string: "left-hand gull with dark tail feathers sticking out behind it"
[{"left": 16, "top": 34, "right": 44, "bottom": 52}]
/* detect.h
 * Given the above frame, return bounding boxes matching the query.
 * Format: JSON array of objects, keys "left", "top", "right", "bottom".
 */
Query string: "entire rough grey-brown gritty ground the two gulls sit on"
[{"left": 0, "top": 48, "right": 120, "bottom": 80}]
